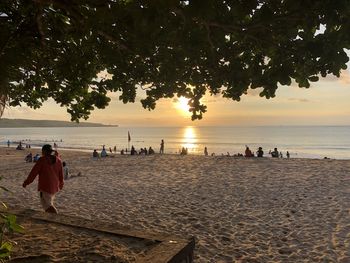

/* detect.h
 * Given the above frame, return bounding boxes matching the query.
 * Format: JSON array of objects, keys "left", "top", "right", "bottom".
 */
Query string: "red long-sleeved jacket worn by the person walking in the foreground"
[{"left": 23, "top": 156, "right": 63, "bottom": 194}]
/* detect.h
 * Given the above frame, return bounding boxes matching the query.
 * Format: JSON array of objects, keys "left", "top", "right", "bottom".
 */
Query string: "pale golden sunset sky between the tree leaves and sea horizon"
[{"left": 3, "top": 70, "right": 350, "bottom": 127}]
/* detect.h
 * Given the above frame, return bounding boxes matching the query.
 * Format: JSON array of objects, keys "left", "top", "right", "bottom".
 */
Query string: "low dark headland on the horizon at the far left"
[{"left": 0, "top": 119, "right": 118, "bottom": 128}]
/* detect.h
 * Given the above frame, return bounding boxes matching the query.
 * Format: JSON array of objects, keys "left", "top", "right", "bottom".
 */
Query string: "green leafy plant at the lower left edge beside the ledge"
[{"left": 0, "top": 177, "right": 24, "bottom": 262}]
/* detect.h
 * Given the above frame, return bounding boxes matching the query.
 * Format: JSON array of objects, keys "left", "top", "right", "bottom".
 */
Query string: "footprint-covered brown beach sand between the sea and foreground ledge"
[{"left": 0, "top": 148, "right": 350, "bottom": 263}]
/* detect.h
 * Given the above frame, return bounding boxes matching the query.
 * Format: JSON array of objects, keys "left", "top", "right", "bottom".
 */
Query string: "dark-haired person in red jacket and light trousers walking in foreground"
[{"left": 22, "top": 144, "right": 64, "bottom": 214}]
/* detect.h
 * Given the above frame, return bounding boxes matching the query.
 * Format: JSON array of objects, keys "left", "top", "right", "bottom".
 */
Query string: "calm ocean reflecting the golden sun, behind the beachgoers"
[{"left": 0, "top": 126, "right": 350, "bottom": 159}]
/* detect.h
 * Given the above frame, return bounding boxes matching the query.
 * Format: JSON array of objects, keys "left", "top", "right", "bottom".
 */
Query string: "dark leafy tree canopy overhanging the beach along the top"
[{"left": 0, "top": 0, "right": 350, "bottom": 121}]
